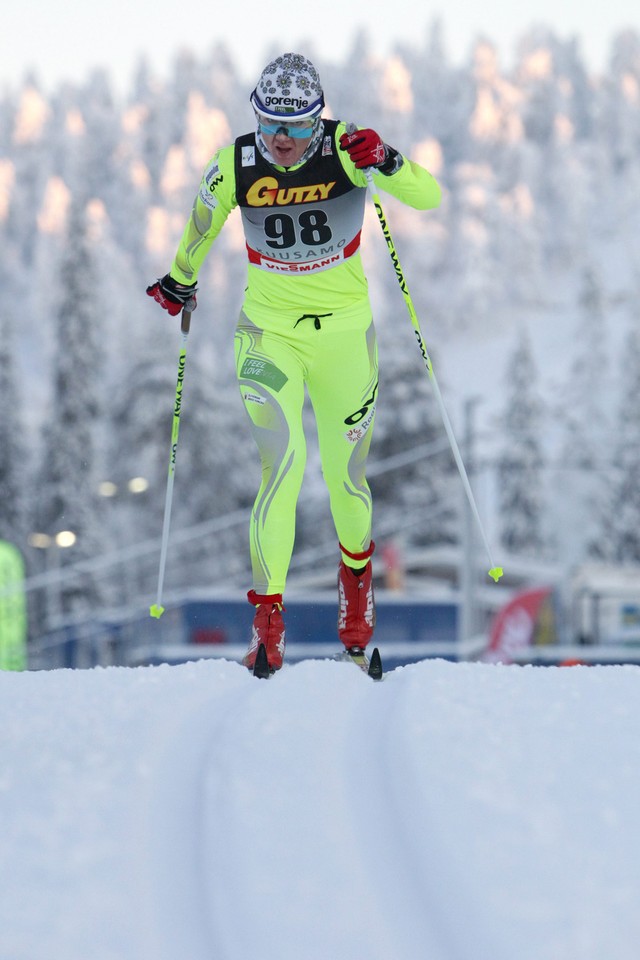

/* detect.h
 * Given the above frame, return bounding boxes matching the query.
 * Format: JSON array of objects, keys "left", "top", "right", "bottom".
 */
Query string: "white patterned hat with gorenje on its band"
[{"left": 250, "top": 53, "right": 324, "bottom": 120}]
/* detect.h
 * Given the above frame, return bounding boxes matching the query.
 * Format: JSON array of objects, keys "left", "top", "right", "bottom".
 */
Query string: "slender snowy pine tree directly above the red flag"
[{"left": 498, "top": 331, "right": 544, "bottom": 556}]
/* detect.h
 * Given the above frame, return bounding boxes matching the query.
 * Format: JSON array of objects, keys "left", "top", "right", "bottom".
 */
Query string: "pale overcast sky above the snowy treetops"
[{"left": 5, "top": 0, "right": 640, "bottom": 90}]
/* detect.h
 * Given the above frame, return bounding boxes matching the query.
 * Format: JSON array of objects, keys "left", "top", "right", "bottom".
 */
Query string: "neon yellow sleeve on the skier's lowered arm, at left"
[{"left": 169, "top": 144, "right": 237, "bottom": 284}]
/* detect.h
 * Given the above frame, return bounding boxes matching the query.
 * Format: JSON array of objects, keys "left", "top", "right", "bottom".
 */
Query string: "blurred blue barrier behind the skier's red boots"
[{"left": 30, "top": 595, "right": 468, "bottom": 669}]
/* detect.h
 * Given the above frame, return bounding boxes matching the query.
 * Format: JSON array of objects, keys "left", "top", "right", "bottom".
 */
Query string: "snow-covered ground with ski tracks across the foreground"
[{"left": 0, "top": 660, "right": 640, "bottom": 960}]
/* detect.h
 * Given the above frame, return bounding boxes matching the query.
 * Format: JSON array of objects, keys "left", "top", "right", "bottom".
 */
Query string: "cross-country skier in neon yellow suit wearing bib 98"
[{"left": 147, "top": 53, "right": 440, "bottom": 671}]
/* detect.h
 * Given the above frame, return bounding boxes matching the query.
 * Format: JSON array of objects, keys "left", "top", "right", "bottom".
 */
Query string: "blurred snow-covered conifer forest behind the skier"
[{"left": 0, "top": 24, "right": 640, "bottom": 632}]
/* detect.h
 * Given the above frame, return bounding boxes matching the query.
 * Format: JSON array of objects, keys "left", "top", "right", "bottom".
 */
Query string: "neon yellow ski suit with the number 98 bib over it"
[{"left": 170, "top": 120, "right": 440, "bottom": 595}]
